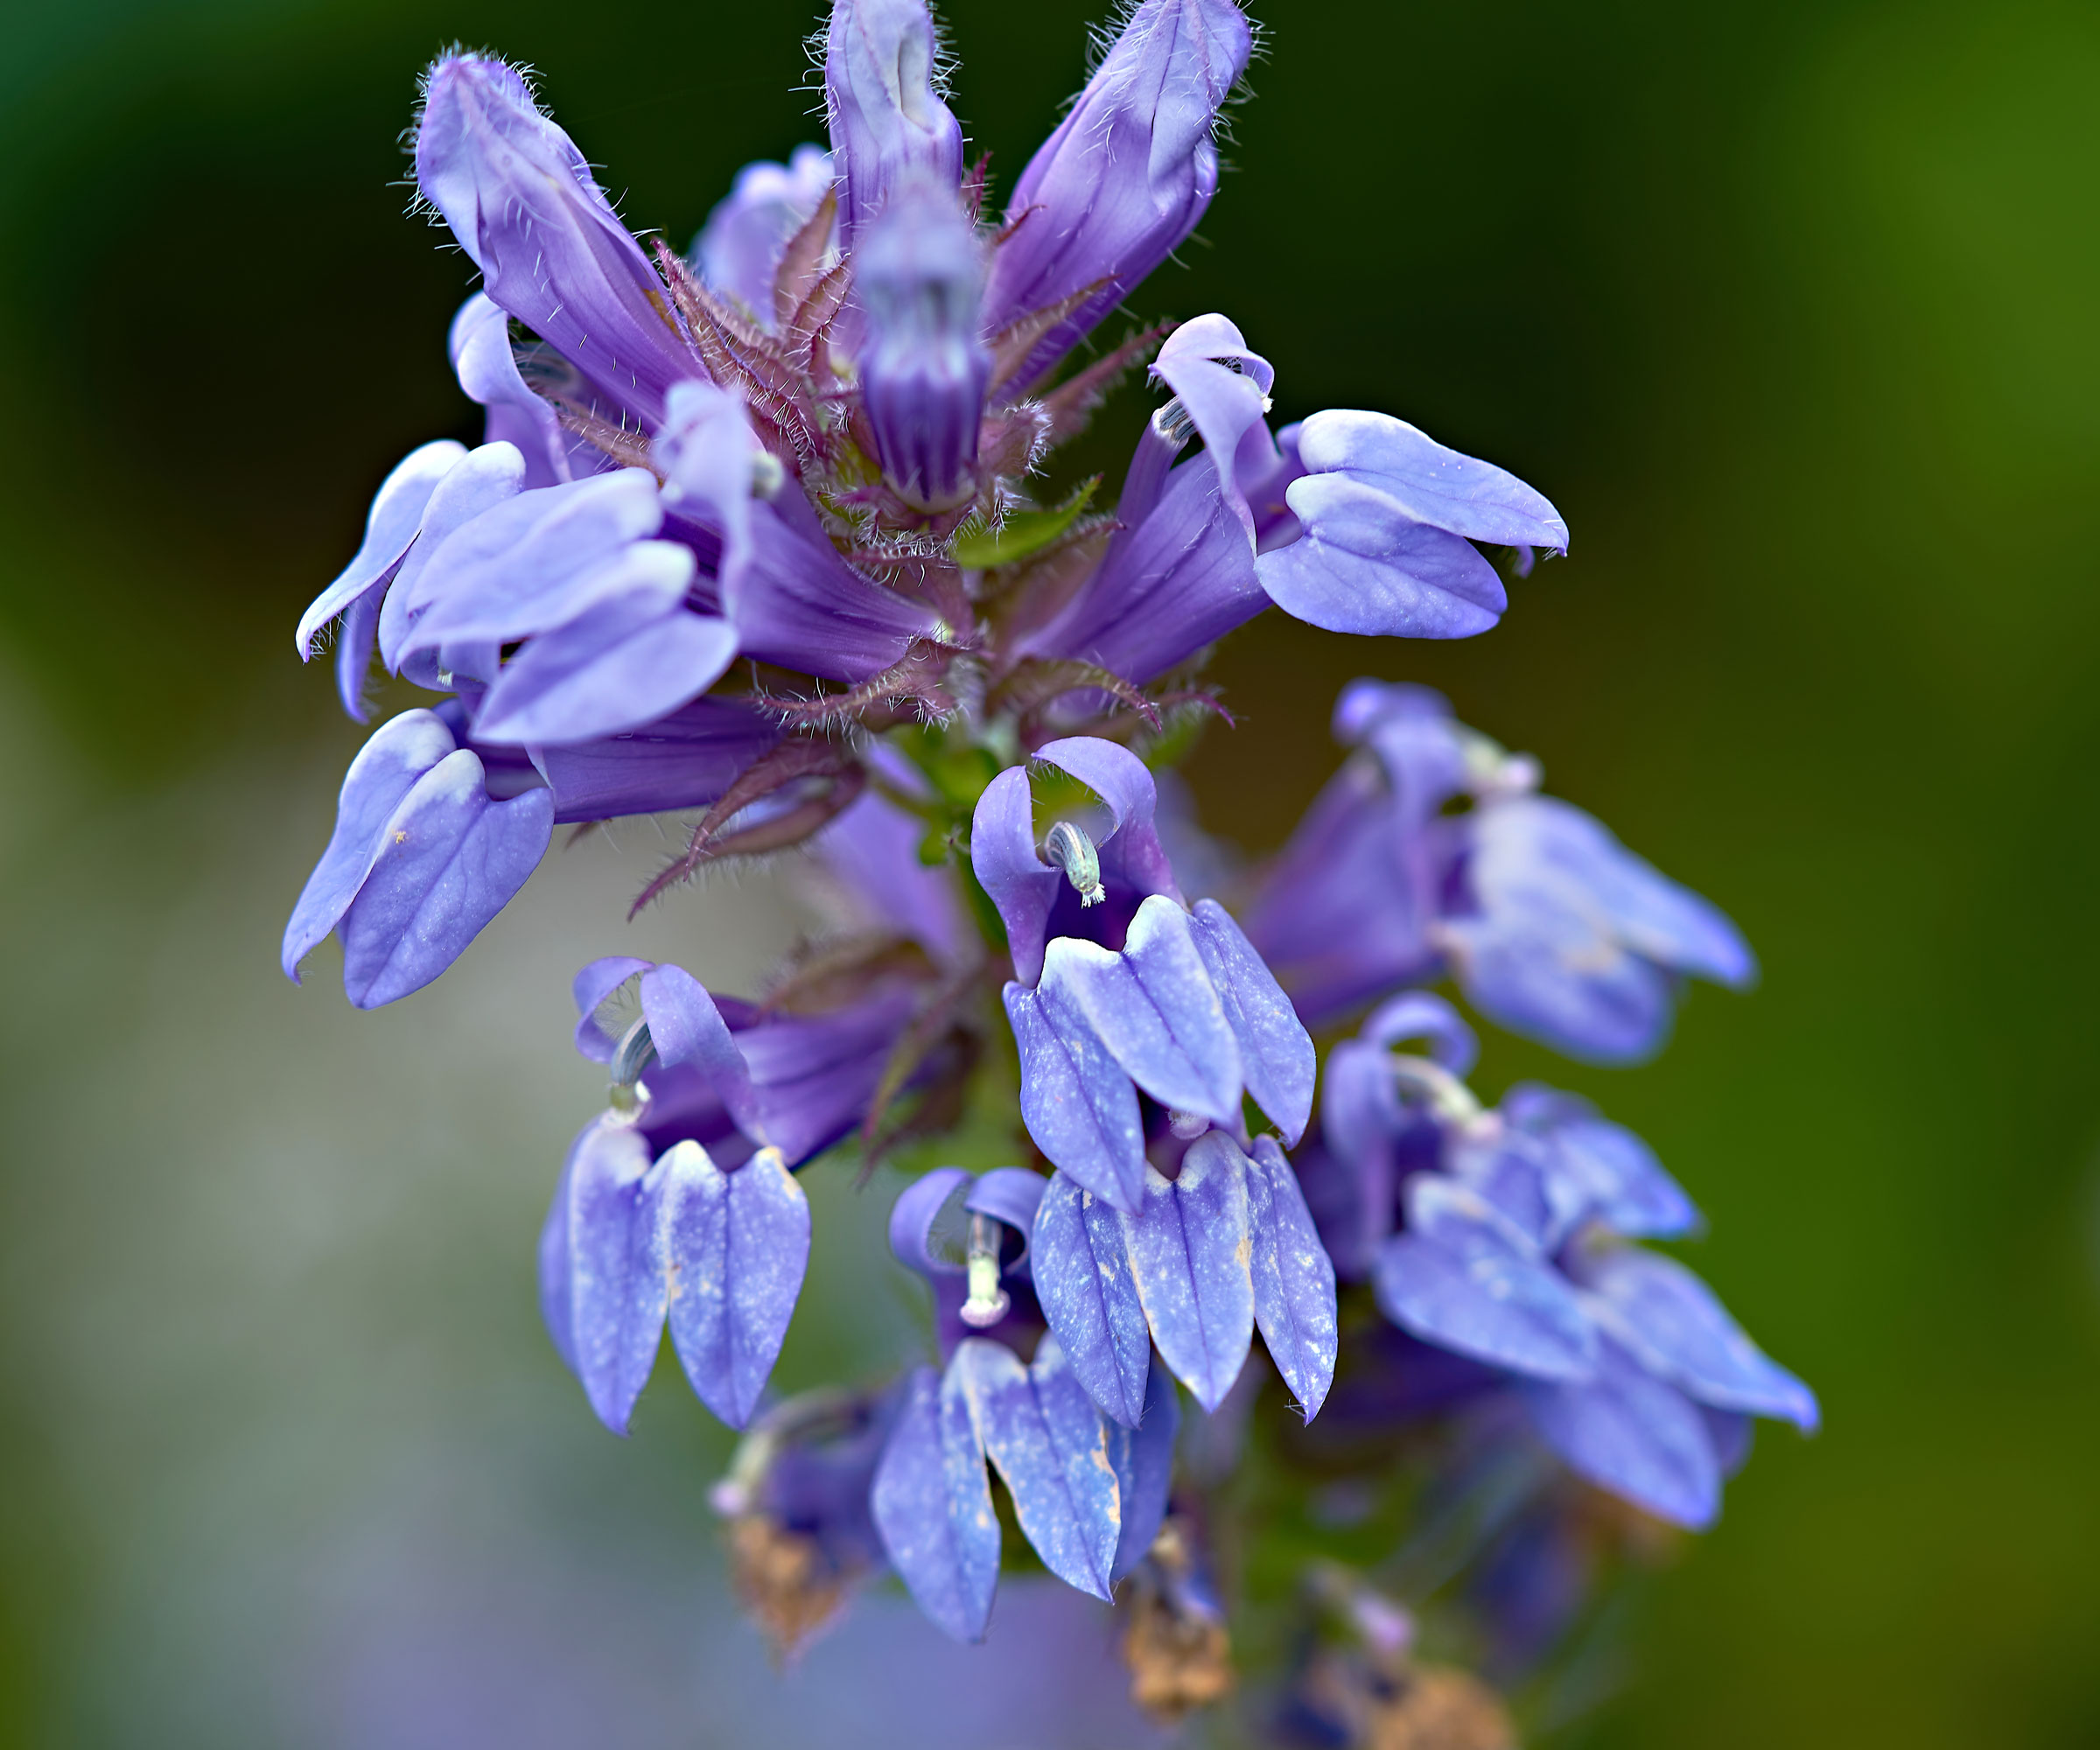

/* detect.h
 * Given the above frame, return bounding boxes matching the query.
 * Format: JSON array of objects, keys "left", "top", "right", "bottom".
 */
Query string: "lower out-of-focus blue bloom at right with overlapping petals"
[{"left": 1306, "top": 994, "right": 1818, "bottom": 1530}]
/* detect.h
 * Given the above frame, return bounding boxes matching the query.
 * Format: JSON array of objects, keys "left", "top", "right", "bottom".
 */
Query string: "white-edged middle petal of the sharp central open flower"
[{"left": 1041, "top": 892, "right": 1241, "bottom": 1124}]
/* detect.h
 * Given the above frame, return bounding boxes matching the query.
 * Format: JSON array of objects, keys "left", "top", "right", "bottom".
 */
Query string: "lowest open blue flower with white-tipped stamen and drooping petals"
[{"left": 870, "top": 1168, "right": 1180, "bottom": 1641}]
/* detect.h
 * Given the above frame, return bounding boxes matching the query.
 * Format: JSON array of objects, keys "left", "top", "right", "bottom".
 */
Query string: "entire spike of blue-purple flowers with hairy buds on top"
[{"left": 284, "top": 0, "right": 1815, "bottom": 1731}]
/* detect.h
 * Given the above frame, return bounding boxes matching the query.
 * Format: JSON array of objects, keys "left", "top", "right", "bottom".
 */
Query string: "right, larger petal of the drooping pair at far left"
[{"left": 338, "top": 748, "right": 555, "bottom": 1008}]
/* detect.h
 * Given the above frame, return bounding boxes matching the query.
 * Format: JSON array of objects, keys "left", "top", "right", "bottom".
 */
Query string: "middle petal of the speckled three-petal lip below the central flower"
[{"left": 1122, "top": 1130, "right": 1254, "bottom": 1410}]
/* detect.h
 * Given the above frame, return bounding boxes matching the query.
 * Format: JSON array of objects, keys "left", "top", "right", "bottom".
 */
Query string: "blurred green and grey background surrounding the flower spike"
[{"left": 0, "top": 0, "right": 2100, "bottom": 1750}]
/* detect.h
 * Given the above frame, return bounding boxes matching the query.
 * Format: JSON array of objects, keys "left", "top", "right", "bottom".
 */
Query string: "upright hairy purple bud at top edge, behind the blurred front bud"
[{"left": 823, "top": 0, "right": 962, "bottom": 248}]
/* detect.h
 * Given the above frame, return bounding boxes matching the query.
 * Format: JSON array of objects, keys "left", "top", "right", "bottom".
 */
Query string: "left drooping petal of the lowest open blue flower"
[{"left": 870, "top": 1368, "right": 999, "bottom": 1641}]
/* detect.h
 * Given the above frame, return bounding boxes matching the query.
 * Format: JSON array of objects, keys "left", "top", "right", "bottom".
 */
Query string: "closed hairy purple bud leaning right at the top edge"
[{"left": 985, "top": 0, "right": 1254, "bottom": 387}]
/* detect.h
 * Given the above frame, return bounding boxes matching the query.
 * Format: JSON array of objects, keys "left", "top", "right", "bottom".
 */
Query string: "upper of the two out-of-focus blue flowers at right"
[{"left": 1248, "top": 681, "right": 1755, "bottom": 1063}]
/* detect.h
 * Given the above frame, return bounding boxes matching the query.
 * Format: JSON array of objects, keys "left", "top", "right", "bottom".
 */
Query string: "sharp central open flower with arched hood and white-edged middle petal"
[{"left": 970, "top": 735, "right": 1312, "bottom": 1209}]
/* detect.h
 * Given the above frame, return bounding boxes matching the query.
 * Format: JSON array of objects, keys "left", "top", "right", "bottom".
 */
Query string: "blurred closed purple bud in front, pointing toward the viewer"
[{"left": 855, "top": 183, "right": 991, "bottom": 510}]
